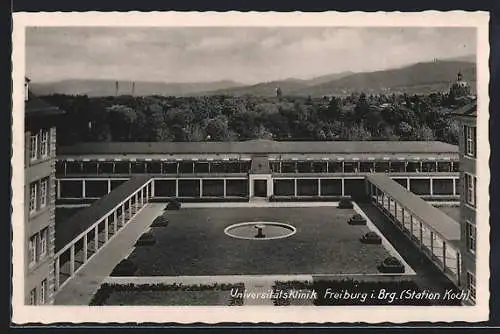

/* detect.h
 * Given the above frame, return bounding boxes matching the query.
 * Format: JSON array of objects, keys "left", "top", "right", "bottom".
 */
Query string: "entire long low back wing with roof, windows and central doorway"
[{"left": 56, "top": 140, "right": 459, "bottom": 202}]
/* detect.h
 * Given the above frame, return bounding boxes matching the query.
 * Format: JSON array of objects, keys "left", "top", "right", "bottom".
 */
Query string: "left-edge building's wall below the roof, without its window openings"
[{"left": 24, "top": 126, "right": 56, "bottom": 304}]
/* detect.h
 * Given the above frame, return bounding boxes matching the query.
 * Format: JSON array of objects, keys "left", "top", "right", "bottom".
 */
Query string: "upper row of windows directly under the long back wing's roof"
[{"left": 56, "top": 161, "right": 459, "bottom": 176}]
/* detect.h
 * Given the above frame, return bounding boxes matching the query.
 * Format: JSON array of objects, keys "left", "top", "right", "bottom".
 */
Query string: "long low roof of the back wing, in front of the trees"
[{"left": 58, "top": 140, "right": 458, "bottom": 155}]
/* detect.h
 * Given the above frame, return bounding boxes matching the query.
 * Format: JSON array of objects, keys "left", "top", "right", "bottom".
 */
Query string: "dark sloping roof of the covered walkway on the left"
[{"left": 55, "top": 175, "right": 151, "bottom": 252}]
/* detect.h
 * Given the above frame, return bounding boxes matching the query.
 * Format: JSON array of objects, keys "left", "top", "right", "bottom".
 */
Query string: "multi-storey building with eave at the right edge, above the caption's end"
[{"left": 455, "top": 103, "right": 477, "bottom": 304}]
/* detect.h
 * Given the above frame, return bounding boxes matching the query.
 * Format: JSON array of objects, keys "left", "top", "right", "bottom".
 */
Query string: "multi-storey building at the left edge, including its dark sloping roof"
[{"left": 24, "top": 79, "right": 62, "bottom": 305}]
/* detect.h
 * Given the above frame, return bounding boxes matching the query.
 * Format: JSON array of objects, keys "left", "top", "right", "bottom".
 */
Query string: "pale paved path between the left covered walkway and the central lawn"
[{"left": 54, "top": 203, "right": 165, "bottom": 305}]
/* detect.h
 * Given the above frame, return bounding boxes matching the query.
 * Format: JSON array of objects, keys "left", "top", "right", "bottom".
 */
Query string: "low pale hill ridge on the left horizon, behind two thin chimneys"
[{"left": 30, "top": 80, "right": 243, "bottom": 97}]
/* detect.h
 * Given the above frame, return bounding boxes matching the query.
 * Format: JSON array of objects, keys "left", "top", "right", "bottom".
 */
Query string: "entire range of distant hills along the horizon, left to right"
[{"left": 31, "top": 55, "right": 476, "bottom": 97}]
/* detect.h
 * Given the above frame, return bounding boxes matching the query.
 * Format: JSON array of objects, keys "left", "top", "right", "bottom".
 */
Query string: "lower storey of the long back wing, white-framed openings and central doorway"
[{"left": 56, "top": 173, "right": 459, "bottom": 200}]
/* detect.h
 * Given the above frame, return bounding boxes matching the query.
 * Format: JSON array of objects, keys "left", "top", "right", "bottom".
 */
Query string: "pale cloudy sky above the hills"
[{"left": 26, "top": 27, "right": 476, "bottom": 83}]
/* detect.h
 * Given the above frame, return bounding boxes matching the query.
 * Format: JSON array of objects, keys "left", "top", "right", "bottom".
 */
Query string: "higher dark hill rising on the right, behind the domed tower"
[{"left": 292, "top": 61, "right": 476, "bottom": 97}]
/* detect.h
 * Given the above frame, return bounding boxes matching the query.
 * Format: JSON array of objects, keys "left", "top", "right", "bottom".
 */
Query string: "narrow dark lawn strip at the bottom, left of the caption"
[{"left": 104, "top": 290, "right": 236, "bottom": 306}]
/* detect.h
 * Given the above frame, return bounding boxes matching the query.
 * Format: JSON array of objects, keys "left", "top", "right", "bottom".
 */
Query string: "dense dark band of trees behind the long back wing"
[{"left": 43, "top": 93, "right": 470, "bottom": 145}]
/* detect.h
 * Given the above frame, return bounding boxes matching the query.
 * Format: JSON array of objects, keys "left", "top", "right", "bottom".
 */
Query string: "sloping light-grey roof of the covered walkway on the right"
[{"left": 367, "top": 173, "right": 460, "bottom": 241}]
